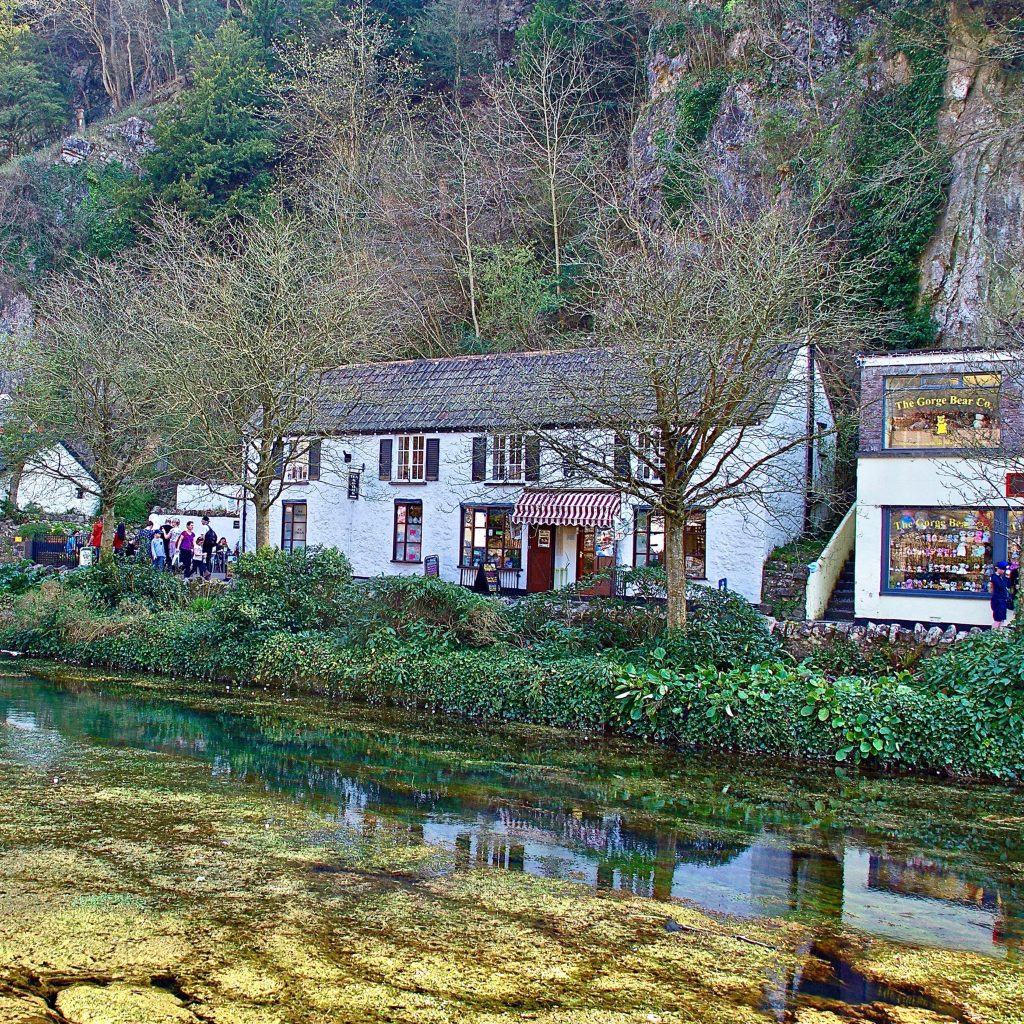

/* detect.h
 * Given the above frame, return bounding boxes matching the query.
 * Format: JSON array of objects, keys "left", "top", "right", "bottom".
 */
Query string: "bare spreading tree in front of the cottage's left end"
[{"left": 146, "top": 214, "right": 398, "bottom": 547}]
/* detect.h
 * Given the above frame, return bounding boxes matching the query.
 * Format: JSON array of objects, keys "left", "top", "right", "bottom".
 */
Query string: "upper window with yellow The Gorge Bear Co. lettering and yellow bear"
[{"left": 885, "top": 373, "right": 1000, "bottom": 449}]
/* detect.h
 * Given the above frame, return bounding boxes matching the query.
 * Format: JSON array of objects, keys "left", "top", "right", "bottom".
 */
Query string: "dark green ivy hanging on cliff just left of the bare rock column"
[{"left": 850, "top": 14, "right": 949, "bottom": 348}]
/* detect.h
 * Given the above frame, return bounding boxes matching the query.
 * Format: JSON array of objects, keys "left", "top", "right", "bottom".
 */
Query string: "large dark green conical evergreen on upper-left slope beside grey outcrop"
[{"left": 145, "top": 20, "right": 276, "bottom": 220}]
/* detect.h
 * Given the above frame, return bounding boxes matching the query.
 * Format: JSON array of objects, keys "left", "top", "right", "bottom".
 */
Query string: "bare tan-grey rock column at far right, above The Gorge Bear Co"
[{"left": 922, "top": 10, "right": 1024, "bottom": 346}]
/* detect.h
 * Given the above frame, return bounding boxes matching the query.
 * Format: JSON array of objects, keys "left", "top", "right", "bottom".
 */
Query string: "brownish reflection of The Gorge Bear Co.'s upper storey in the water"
[{"left": 867, "top": 854, "right": 1024, "bottom": 950}]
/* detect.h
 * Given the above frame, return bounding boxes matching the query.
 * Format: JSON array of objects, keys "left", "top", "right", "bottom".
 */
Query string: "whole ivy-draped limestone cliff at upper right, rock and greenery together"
[{"left": 631, "top": 0, "right": 1024, "bottom": 346}]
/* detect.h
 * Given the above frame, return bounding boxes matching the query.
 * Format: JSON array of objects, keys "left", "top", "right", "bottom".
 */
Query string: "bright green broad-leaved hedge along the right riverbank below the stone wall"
[{"left": 611, "top": 650, "right": 1024, "bottom": 778}]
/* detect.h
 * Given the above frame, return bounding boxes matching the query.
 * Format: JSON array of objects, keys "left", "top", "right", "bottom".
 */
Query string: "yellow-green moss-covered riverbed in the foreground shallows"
[{"left": 0, "top": 678, "right": 1024, "bottom": 1024}]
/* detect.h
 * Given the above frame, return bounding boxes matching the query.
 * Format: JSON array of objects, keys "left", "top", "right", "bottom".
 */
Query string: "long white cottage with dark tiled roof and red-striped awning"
[{"left": 235, "top": 350, "right": 833, "bottom": 603}]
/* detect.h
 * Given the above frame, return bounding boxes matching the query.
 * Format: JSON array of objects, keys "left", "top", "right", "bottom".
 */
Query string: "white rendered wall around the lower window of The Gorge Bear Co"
[{"left": 854, "top": 456, "right": 1024, "bottom": 626}]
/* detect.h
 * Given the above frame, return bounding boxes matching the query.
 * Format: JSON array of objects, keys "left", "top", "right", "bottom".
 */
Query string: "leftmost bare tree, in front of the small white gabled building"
[{"left": 10, "top": 260, "right": 173, "bottom": 538}]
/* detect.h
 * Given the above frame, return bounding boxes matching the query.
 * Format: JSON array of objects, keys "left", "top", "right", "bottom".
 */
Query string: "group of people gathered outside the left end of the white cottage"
[{"left": 66, "top": 516, "right": 230, "bottom": 579}]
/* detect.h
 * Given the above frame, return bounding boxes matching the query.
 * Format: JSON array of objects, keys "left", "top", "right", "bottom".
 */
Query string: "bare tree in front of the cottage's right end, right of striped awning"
[{"left": 519, "top": 202, "right": 882, "bottom": 629}]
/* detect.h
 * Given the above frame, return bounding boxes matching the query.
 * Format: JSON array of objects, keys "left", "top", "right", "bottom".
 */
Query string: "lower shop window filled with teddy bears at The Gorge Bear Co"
[{"left": 888, "top": 509, "right": 995, "bottom": 594}]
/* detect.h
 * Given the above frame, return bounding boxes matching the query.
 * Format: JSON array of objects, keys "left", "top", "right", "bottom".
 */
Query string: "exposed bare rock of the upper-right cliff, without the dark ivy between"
[{"left": 631, "top": 0, "right": 1024, "bottom": 347}]
